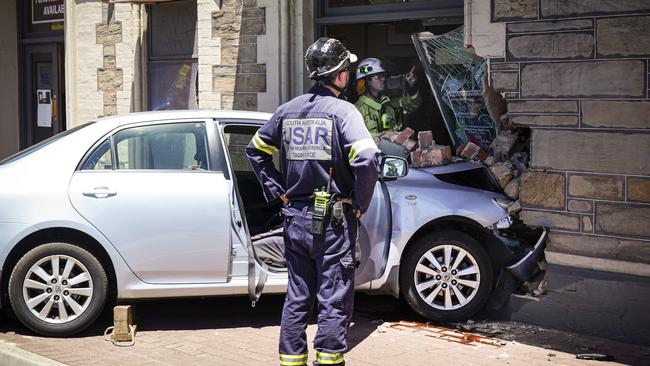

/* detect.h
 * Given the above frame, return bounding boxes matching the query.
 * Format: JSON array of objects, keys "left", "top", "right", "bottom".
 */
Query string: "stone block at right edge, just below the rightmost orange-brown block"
[{"left": 595, "top": 202, "right": 650, "bottom": 238}]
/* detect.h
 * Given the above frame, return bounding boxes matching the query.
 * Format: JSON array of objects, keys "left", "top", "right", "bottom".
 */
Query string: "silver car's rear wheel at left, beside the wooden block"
[{"left": 9, "top": 243, "right": 108, "bottom": 336}]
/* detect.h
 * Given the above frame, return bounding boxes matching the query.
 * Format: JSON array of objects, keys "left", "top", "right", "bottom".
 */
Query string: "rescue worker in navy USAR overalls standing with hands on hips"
[{"left": 246, "top": 38, "right": 379, "bottom": 366}]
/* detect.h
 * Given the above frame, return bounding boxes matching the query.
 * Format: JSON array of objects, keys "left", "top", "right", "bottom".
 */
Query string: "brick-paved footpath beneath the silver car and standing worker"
[{"left": 0, "top": 294, "right": 650, "bottom": 366}]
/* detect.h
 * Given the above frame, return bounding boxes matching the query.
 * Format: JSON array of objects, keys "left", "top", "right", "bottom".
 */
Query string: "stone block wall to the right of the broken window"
[{"left": 489, "top": 0, "right": 650, "bottom": 276}]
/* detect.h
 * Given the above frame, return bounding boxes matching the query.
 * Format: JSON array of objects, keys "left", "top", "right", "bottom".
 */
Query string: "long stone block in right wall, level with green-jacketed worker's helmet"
[{"left": 521, "top": 60, "right": 646, "bottom": 98}]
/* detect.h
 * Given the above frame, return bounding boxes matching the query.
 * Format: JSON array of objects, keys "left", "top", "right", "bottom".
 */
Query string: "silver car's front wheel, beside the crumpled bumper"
[{"left": 400, "top": 230, "right": 493, "bottom": 321}]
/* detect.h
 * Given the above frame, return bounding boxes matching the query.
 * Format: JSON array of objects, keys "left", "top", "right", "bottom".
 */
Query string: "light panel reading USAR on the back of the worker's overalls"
[{"left": 282, "top": 118, "right": 332, "bottom": 161}]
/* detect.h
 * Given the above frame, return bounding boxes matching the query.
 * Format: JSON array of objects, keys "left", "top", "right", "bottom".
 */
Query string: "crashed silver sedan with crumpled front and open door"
[{"left": 0, "top": 111, "right": 545, "bottom": 336}]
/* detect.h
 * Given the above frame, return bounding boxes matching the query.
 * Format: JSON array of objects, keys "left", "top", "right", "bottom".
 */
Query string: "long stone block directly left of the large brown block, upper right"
[{"left": 506, "top": 31, "right": 595, "bottom": 61}]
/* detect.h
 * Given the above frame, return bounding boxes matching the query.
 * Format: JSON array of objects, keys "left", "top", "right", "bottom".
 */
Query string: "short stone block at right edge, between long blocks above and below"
[{"left": 582, "top": 100, "right": 650, "bottom": 128}]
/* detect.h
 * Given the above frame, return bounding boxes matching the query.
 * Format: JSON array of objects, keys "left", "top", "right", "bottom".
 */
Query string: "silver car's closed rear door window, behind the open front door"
[{"left": 113, "top": 122, "right": 209, "bottom": 170}]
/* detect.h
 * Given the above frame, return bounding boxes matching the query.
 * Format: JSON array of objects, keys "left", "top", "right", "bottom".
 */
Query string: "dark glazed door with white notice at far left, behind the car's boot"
[{"left": 21, "top": 43, "right": 66, "bottom": 149}]
